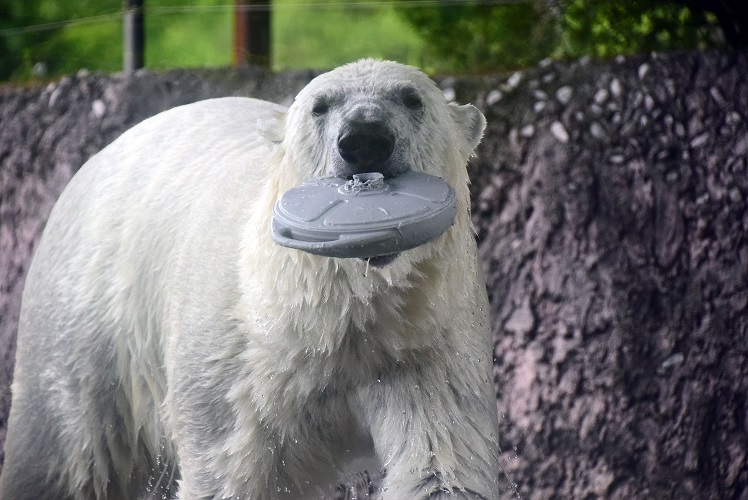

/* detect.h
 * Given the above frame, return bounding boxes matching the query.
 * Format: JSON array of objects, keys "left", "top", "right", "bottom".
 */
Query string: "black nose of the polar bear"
[{"left": 338, "top": 122, "right": 395, "bottom": 167}]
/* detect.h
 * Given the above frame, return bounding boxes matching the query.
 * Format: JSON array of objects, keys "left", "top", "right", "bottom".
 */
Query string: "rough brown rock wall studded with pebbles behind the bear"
[{"left": 0, "top": 49, "right": 748, "bottom": 499}]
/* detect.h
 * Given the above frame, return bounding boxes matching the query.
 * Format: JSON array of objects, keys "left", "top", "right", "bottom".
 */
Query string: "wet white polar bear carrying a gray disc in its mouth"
[{"left": 0, "top": 60, "right": 499, "bottom": 500}]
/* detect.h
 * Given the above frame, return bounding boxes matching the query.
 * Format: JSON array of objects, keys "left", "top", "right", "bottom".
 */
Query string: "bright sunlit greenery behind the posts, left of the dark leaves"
[{"left": 0, "top": 0, "right": 424, "bottom": 80}]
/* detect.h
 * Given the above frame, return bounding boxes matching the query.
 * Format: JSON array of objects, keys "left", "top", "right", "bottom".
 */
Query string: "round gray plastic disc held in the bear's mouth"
[{"left": 272, "top": 172, "right": 457, "bottom": 258}]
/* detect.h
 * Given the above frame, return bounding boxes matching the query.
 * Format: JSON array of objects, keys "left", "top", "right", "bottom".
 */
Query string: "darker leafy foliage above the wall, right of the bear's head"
[{"left": 399, "top": 0, "right": 722, "bottom": 73}]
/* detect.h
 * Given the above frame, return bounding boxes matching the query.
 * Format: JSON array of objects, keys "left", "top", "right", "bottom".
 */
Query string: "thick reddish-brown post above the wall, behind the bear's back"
[{"left": 233, "top": 0, "right": 270, "bottom": 68}]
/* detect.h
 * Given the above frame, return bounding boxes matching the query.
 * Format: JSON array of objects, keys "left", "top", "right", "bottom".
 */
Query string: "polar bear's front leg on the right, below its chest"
[{"left": 359, "top": 363, "right": 499, "bottom": 500}]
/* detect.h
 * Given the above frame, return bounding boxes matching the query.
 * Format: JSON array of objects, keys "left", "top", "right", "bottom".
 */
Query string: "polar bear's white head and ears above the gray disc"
[{"left": 283, "top": 59, "right": 486, "bottom": 181}]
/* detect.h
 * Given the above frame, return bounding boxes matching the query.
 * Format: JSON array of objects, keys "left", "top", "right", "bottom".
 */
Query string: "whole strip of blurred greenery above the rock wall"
[{"left": 0, "top": 0, "right": 748, "bottom": 82}]
